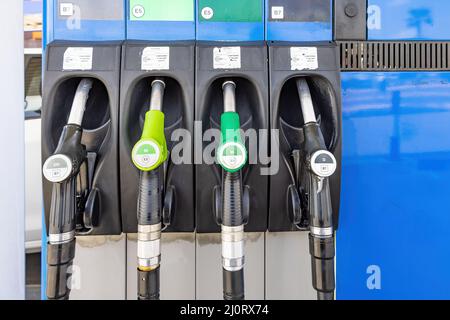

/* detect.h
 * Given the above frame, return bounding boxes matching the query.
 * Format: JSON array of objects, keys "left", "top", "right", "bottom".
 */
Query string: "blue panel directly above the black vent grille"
[{"left": 368, "top": 0, "right": 450, "bottom": 40}]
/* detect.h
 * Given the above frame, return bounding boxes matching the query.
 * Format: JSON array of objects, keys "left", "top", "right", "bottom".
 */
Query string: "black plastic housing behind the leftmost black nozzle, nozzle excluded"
[{"left": 42, "top": 41, "right": 122, "bottom": 235}]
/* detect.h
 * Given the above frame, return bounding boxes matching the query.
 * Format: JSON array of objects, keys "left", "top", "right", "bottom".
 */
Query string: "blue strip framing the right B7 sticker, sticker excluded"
[{"left": 265, "top": 0, "right": 333, "bottom": 42}]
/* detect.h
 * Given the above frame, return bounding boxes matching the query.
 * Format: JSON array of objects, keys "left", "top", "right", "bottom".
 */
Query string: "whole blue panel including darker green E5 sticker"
[{"left": 196, "top": 0, "right": 265, "bottom": 41}]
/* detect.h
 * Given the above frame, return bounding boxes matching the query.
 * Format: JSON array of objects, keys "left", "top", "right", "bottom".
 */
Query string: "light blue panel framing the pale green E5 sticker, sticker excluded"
[{"left": 126, "top": 0, "right": 195, "bottom": 41}]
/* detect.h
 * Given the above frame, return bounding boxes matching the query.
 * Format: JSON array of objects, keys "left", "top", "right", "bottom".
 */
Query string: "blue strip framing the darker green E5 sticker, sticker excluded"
[{"left": 196, "top": 0, "right": 265, "bottom": 41}]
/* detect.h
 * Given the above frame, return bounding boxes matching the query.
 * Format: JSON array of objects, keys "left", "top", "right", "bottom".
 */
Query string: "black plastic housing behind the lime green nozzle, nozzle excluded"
[{"left": 119, "top": 41, "right": 195, "bottom": 233}]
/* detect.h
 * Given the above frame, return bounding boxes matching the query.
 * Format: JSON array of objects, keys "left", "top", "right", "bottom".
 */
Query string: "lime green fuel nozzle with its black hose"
[{"left": 132, "top": 79, "right": 168, "bottom": 300}]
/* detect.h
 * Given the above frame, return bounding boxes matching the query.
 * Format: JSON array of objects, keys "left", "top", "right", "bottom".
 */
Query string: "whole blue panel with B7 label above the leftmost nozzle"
[{"left": 46, "top": 0, "right": 125, "bottom": 42}]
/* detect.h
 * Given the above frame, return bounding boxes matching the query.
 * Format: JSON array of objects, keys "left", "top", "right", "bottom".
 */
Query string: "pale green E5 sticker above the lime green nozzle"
[{"left": 130, "top": 0, "right": 194, "bottom": 21}]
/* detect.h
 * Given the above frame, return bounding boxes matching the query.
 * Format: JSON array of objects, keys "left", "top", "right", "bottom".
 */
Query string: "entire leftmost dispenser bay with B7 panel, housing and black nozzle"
[{"left": 42, "top": 0, "right": 124, "bottom": 299}]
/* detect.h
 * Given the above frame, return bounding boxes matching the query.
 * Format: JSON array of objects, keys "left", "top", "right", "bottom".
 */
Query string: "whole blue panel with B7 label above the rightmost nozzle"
[{"left": 266, "top": 0, "right": 333, "bottom": 42}]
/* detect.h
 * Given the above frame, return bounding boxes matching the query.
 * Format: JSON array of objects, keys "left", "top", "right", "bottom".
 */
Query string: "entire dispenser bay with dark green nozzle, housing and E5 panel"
[{"left": 195, "top": 0, "right": 268, "bottom": 300}]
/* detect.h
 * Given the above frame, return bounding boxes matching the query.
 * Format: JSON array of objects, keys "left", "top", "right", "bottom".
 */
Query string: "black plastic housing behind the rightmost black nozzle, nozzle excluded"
[{"left": 269, "top": 42, "right": 342, "bottom": 232}]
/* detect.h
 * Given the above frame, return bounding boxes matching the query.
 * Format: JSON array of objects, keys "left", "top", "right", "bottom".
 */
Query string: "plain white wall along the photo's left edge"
[{"left": 0, "top": 0, "right": 24, "bottom": 299}]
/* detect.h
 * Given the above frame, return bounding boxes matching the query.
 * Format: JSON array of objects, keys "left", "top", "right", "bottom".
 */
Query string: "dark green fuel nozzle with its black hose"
[{"left": 215, "top": 81, "right": 248, "bottom": 300}]
